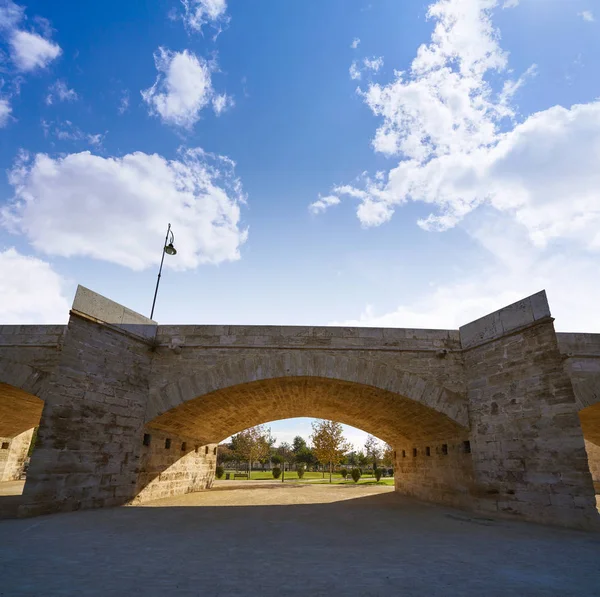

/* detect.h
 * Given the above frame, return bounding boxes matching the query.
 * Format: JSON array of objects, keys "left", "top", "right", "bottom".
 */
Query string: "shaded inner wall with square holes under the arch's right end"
[{"left": 394, "top": 435, "right": 474, "bottom": 508}]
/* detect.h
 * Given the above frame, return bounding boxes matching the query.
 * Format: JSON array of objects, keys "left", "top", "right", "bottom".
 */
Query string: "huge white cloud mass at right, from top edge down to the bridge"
[{"left": 321, "top": 0, "right": 600, "bottom": 331}]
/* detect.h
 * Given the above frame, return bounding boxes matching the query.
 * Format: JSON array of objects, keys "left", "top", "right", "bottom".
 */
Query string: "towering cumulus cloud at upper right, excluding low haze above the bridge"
[{"left": 318, "top": 0, "right": 600, "bottom": 248}]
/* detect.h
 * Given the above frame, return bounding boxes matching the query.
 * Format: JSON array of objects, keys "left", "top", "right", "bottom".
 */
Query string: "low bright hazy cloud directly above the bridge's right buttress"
[{"left": 331, "top": 213, "right": 600, "bottom": 333}]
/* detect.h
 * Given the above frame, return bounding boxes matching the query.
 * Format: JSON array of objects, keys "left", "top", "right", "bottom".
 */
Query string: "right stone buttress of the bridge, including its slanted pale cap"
[{"left": 461, "top": 293, "right": 600, "bottom": 528}]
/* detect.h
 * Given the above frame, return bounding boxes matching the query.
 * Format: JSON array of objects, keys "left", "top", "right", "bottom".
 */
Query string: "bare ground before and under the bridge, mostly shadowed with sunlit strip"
[{"left": 0, "top": 484, "right": 600, "bottom": 597}]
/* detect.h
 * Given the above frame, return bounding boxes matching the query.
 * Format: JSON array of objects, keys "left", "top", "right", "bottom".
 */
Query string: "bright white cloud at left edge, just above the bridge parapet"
[{"left": 0, "top": 248, "right": 70, "bottom": 324}]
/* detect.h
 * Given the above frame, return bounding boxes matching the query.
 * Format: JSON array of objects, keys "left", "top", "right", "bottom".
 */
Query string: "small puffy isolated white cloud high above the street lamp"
[{"left": 141, "top": 48, "right": 213, "bottom": 129}]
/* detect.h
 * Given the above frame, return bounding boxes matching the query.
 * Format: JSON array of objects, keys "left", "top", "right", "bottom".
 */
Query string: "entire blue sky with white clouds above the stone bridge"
[{"left": 0, "top": 0, "right": 600, "bottom": 448}]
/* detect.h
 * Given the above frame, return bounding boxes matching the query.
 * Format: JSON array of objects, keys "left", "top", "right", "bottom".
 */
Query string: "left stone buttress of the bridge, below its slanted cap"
[{"left": 20, "top": 314, "right": 152, "bottom": 516}]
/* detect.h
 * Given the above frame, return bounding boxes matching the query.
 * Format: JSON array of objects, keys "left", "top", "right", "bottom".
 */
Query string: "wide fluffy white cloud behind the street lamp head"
[{"left": 0, "top": 149, "right": 247, "bottom": 270}]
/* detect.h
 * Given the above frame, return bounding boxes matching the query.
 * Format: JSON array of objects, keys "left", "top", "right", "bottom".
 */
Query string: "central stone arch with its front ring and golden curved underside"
[{"left": 146, "top": 351, "right": 469, "bottom": 444}]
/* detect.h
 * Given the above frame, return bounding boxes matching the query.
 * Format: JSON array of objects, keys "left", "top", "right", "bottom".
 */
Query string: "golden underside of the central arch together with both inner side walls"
[{"left": 135, "top": 375, "right": 473, "bottom": 503}]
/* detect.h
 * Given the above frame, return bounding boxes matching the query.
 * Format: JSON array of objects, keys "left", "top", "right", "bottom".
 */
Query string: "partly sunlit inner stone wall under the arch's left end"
[{"left": 132, "top": 429, "right": 217, "bottom": 504}]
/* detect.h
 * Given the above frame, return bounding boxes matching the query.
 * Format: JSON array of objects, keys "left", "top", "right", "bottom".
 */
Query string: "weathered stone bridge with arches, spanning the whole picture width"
[{"left": 0, "top": 286, "right": 600, "bottom": 528}]
